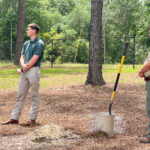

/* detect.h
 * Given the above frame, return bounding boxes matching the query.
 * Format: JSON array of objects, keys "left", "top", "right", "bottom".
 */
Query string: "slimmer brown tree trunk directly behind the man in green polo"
[{"left": 14, "top": 0, "right": 25, "bottom": 65}]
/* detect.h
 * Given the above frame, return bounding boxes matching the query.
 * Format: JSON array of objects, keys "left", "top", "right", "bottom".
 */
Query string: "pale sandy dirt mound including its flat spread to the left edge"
[{"left": 0, "top": 124, "right": 82, "bottom": 150}]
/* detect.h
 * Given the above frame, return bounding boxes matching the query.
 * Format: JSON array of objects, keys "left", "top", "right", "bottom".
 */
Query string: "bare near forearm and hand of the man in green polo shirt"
[{"left": 23, "top": 55, "right": 40, "bottom": 72}]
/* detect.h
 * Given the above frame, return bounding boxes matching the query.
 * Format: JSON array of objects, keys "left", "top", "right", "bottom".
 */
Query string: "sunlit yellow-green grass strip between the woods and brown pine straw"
[{"left": 0, "top": 62, "right": 144, "bottom": 90}]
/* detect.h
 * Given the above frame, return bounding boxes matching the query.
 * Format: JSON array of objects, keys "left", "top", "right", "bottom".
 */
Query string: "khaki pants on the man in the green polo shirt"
[{"left": 11, "top": 67, "right": 41, "bottom": 120}]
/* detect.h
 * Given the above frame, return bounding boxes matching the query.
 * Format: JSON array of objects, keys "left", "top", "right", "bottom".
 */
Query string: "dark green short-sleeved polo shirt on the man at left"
[{"left": 21, "top": 37, "right": 44, "bottom": 67}]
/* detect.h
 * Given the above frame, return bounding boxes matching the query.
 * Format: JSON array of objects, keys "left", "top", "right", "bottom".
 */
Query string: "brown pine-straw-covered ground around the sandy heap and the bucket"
[{"left": 0, "top": 83, "right": 150, "bottom": 150}]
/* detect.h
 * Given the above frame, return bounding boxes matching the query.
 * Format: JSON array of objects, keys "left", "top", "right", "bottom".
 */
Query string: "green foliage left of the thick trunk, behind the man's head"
[{"left": 0, "top": 0, "right": 90, "bottom": 64}]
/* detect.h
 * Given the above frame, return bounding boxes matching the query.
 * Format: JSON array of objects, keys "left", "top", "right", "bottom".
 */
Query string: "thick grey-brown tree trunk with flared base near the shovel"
[{"left": 85, "top": 0, "right": 105, "bottom": 85}]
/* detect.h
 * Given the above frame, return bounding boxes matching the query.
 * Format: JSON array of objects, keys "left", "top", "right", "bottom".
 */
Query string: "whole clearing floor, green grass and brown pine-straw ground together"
[{"left": 0, "top": 63, "right": 150, "bottom": 150}]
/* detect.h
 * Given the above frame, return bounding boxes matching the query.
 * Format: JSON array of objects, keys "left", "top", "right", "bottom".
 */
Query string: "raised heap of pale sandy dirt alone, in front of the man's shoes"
[{"left": 30, "top": 124, "right": 81, "bottom": 145}]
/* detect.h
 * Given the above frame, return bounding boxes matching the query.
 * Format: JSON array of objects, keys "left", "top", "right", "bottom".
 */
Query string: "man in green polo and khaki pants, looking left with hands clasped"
[{"left": 1, "top": 23, "right": 44, "bottom": 125}]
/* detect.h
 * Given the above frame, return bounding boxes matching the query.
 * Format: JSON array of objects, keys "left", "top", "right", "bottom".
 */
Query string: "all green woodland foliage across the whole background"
[{"left": 0, "top": 0, "right": 150, "bottom": 64}]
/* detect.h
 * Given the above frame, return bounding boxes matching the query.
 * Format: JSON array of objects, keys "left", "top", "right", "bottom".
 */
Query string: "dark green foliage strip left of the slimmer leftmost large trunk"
[{"left": 0, "top": 0, "right": 17, "bottom": 60}]
